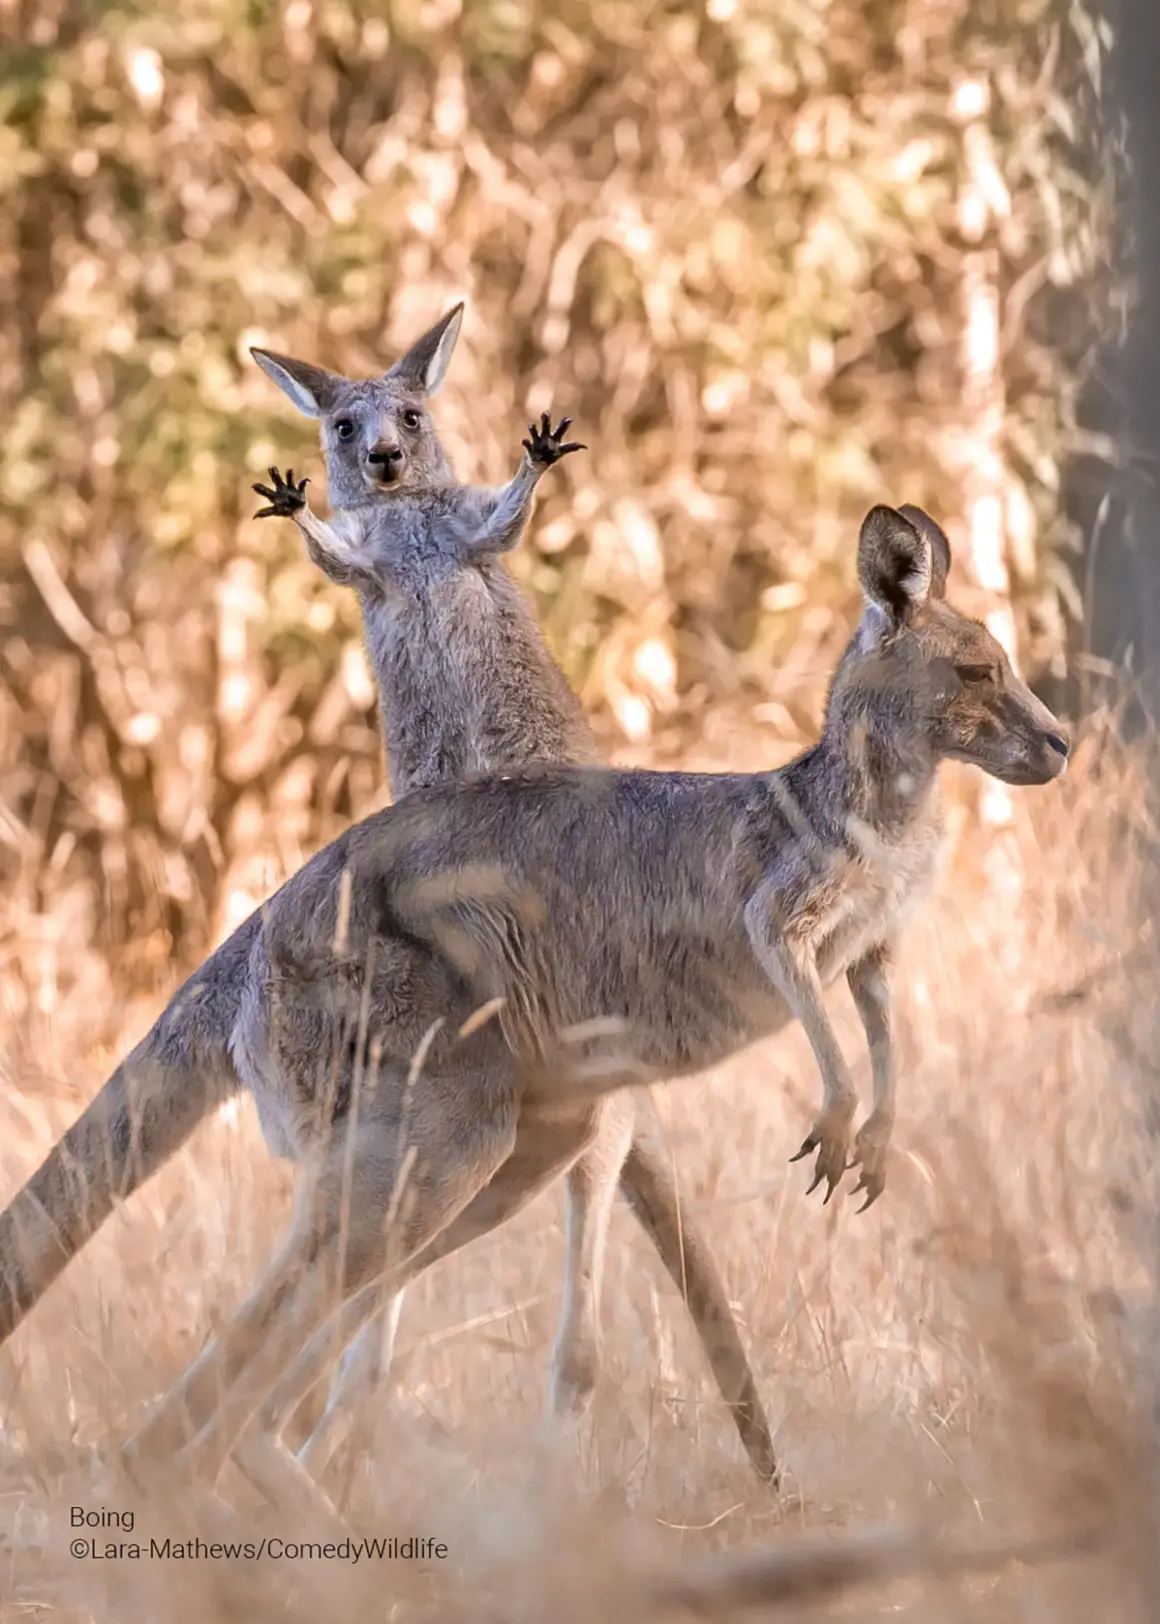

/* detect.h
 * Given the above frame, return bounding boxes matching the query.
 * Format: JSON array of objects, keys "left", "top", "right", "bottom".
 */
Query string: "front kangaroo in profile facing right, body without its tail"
[{"left": 112, "top": 507, "right": 1069, "bottom": 1476}]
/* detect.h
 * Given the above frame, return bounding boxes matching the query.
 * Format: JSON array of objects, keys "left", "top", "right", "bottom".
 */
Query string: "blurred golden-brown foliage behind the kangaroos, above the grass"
[{"left": 0, "top": 0, "right": 1111, "bottom": 974}]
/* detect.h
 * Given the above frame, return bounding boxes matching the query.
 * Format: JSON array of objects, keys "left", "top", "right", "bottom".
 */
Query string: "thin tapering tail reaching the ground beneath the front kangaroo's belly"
[{"left": 621, "top": 1112, "right": 778, "bottom": 1486}]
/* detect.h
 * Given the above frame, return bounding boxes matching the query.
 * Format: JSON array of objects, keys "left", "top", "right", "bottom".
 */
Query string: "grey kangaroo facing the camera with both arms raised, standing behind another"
[{"left": 243, "top": 305, "right": 773, "bottom": 1478}]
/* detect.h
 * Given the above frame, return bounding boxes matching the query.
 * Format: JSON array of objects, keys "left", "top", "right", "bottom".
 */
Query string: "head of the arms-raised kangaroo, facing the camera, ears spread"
[{"left": 250, "top": 304, "right": 463, "bottom": 508}]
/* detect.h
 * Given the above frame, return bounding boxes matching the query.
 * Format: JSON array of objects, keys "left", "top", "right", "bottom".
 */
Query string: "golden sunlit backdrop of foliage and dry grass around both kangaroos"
[{"left": 0, "top": 0, "right": 1154, "bottom": 1624}]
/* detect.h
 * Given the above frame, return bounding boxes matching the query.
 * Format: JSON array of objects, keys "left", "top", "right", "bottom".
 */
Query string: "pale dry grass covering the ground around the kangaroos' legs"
[{"left": 0, "top": 717, "right": 1155, "bottom": 1624}]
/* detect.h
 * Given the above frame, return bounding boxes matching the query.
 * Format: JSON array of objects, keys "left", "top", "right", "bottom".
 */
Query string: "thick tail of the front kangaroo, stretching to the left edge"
[{"left": 0, "top": 948, "right": 245, "bottom": 1343}]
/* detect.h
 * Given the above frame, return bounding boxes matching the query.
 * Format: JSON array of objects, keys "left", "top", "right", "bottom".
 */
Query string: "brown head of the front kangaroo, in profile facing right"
[{"left": 827, "top": 507, "right": 1071, "bottom": 784}]
